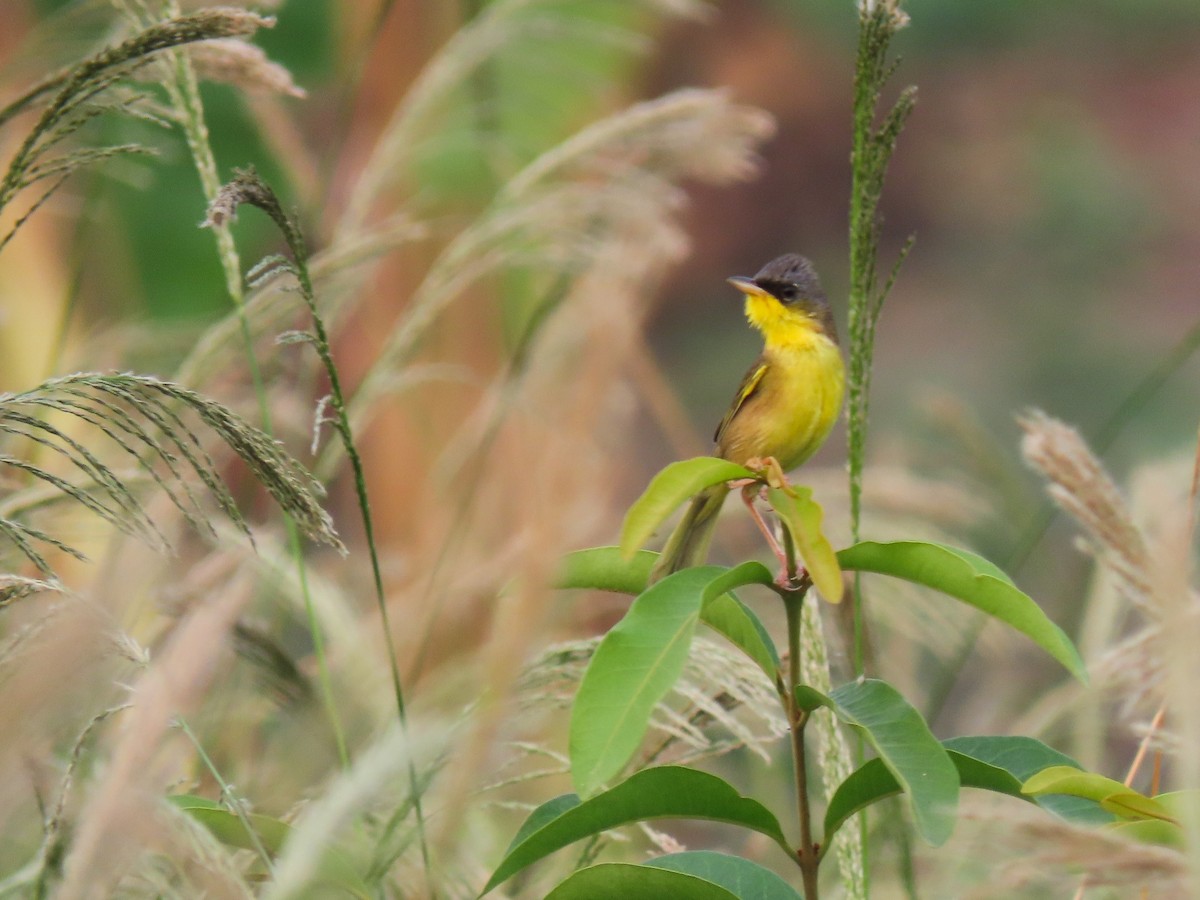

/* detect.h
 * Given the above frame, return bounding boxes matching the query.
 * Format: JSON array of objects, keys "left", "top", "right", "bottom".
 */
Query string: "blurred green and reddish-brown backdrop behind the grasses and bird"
[{"left": 0, "top": 0, "right": 1200, "bottom": 897}]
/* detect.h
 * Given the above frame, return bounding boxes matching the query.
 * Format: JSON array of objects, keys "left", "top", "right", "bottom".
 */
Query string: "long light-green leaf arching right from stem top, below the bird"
[{"left": 838, "top": 541, "right": 1087, "bottom": 683}]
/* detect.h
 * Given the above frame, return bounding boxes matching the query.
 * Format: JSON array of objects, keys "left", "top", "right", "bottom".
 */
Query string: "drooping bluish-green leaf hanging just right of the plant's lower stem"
[{"left": 829, "top": 679, "right": 959, "bottom": 847}]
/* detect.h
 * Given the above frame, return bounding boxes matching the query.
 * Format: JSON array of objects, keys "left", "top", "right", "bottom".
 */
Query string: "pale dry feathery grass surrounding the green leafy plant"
[{"left": 0, "top": 0, "right": 1200, "bottom": 898}]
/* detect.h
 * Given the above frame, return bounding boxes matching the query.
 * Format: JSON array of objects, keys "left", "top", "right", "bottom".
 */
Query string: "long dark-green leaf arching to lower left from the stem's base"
[{"left": 482, "top": 766, "right": 791, "bottom": 894}]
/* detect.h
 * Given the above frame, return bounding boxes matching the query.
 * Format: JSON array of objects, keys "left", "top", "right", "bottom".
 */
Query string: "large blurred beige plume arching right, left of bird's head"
[{"left": 338, "top": 90, "right": 773, "bottom": 453}]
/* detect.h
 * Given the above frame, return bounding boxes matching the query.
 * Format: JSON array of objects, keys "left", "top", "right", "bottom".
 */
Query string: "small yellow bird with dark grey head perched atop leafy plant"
[{"left": 650, "top": 253, "right": 846, "bottom": 581}]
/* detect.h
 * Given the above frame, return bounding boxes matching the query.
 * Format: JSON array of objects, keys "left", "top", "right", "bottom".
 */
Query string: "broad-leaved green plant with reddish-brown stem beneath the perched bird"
[{"left": 485, "top": 457, "right": 1088, "bottom": 896}]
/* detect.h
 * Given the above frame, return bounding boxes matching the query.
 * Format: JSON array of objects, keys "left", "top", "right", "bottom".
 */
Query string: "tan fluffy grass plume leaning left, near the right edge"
[{"left": 1019, "top": 410, "right": 1152, "bottom": 611}]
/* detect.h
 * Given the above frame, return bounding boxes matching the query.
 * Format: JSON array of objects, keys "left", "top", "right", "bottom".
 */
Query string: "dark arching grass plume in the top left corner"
[{"left": 0, "top": 8, "right": 271, "bottom": 248}]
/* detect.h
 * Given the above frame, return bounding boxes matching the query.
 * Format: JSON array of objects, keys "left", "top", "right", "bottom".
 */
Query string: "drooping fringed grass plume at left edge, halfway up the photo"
[{"left": 0, "top": 373, "right": 342, "bottom": 592}]
